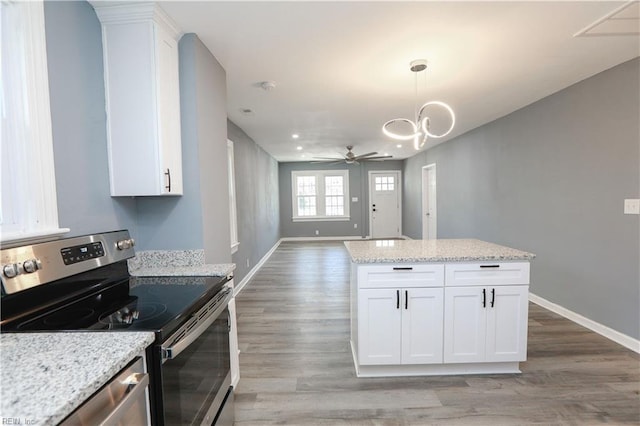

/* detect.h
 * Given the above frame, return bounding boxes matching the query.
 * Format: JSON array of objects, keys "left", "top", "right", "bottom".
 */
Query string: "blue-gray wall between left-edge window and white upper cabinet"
[{"left": 44, "top": 1, "right": 137, "bottom": 237}]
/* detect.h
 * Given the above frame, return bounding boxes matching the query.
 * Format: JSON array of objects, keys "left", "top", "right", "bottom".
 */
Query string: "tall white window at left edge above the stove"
[{"left": 0, "top": 1, "right": 69, "bottom": 243}]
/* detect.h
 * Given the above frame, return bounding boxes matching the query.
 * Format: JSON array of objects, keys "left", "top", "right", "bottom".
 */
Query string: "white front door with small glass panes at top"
[{"left": 369, "top": 171, "right": 402, "bottom": 238}]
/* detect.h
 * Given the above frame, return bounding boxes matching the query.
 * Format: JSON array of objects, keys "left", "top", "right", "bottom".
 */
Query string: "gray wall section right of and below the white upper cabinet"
[{"left": 137, "top": 34, "right": 231, "bottom": 263}]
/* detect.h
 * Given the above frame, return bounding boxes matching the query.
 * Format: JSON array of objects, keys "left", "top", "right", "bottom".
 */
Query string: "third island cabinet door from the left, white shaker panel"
[{"left": 444, "top": 287, "right": 487, "bottom": 363}]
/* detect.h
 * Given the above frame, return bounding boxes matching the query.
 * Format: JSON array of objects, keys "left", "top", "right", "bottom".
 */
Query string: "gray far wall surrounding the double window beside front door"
[{"left": 278, "top": 160, "right": 404, "bottom": 237}]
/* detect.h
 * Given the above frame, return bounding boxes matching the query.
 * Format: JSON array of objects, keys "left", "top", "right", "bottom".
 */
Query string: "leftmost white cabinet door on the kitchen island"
[{"left": 358, "top": 288, "right": 402, "bottom": 365}]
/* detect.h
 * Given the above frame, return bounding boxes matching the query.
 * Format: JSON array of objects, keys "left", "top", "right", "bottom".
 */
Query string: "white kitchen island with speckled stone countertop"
[{"left": 345, "top": 239, "right": 535, "bottom": 377}]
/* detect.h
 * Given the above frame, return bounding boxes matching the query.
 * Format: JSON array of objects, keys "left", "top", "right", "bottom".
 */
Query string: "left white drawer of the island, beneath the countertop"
[{"left": 358, "top": 263, "right": 444, "bottom": 288}]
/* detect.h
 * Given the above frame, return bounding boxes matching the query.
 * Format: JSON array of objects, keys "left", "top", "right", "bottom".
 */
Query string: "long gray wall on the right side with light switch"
[{"left": 404, "top": 59, "right": 640, "bottom": 339}]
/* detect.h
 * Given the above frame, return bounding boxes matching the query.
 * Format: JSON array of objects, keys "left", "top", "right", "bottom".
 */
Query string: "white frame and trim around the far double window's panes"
[{"left": 291, "top": 169, "right": 351, "bottom": 222}]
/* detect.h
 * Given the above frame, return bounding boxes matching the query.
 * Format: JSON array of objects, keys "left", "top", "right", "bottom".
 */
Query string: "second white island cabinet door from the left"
[{"left": 401, "top": 288, "right": 444, "bottom": 364}]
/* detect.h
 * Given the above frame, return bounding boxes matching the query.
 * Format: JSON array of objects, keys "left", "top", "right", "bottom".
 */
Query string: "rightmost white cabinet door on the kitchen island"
[{"left": 486, "top": 286, "right": 529, "bottom": 362}]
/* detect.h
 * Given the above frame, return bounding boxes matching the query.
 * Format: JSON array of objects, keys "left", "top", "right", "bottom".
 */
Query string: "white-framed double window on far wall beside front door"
[{"left": 291, "top": 170, "right": 349, "bottom": 222}]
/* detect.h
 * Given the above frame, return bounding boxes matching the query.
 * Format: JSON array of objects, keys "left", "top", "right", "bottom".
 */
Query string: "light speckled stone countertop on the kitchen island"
[{"left": 344, "top": 239, "right": 535, "bottom": 263}]
